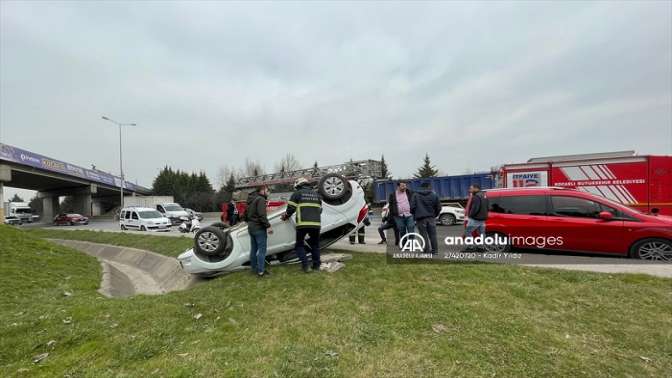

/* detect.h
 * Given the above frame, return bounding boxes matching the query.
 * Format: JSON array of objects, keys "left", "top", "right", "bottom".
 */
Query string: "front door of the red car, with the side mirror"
[{"left": 548, "top": 194, "right": 624, "bottom": 253}]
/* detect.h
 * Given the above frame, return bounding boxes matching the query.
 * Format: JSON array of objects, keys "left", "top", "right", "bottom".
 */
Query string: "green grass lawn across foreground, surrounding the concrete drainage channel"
[{"left": 0, "top": 226, "right": 672, "bottom": 377}]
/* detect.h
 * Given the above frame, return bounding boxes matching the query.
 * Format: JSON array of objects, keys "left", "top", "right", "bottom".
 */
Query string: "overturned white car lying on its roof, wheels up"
[{"left": 177, "top": 174, "right": 368, "bottom": 276}]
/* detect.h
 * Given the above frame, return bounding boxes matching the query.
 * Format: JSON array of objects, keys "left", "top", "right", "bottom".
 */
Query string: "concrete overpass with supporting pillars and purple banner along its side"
[{"left": 0, "top": 143, "right": 150, "bottom": 221}]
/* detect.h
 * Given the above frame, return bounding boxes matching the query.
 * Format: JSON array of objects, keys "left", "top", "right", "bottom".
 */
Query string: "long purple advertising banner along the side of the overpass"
[{"left": 0, "top": 143, "right": 149, "bottom": 191}]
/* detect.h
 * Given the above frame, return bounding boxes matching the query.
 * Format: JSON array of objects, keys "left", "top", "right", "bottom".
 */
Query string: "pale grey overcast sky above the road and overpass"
[{"left": 0, "top": 1, "right": 672, "bottom": 201}]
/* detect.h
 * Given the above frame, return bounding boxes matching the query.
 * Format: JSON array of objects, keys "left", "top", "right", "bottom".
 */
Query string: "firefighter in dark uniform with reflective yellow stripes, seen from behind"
[{"left": 282, "top": 177, "right": 322, "bottom": 273}]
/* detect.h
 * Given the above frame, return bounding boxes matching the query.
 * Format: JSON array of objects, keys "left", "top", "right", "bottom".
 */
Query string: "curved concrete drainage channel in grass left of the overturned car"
[{"left": 50, "top": 239, "right": 199, "bottom": 297}]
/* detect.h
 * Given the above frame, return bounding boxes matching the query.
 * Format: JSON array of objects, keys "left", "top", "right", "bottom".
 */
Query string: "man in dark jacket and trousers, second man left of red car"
[{"left": 411, "top": 181, "right": 441, "bottom": 254}]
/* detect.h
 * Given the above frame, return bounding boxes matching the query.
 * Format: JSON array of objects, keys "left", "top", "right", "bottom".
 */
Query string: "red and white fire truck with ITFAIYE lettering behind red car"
[{"left": 500, "top": 151, "right": 672, "bottom": 215}]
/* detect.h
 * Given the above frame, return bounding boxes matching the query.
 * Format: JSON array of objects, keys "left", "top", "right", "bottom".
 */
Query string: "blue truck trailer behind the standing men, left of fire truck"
[{"left": 373, "top": 172, "right": 497, "bottom": 203}]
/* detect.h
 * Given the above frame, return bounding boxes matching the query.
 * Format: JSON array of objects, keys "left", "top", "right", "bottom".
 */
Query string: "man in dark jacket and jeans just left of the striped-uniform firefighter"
[{"left": 245, "top": 186, "right": 273, "bottom": 277}]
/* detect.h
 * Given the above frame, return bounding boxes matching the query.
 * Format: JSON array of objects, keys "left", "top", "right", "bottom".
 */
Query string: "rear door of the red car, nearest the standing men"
[{"left": 486, "top": 194, "right": 551, "bottom": 248}]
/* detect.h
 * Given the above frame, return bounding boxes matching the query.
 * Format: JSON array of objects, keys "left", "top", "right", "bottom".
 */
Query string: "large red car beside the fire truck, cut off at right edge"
[{"left": 486, "top": 187, "right": 672, "bottom": 261}]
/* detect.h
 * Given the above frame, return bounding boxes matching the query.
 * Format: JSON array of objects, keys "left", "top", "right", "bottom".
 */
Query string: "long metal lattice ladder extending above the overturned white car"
[{"left": 236, "top": 159, "right": 382, "bottom": 189}]
